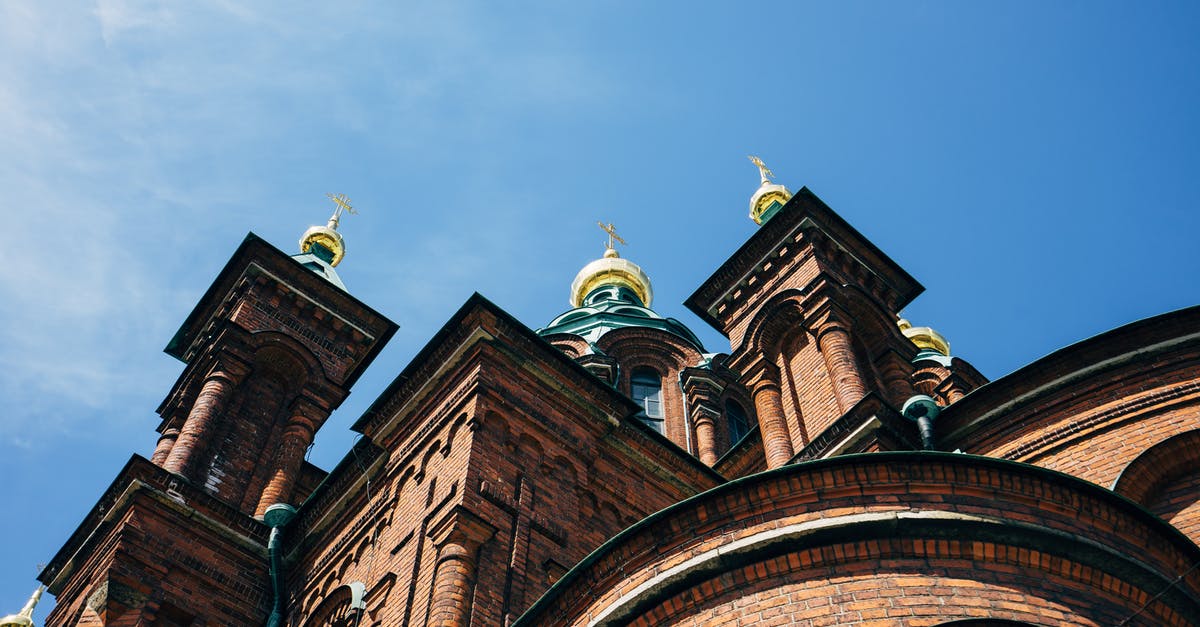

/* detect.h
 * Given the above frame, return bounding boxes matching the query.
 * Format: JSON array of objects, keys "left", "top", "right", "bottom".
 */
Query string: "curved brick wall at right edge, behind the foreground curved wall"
[{"left": 936, "top": 307, "right": 1200, "bottom": 485}]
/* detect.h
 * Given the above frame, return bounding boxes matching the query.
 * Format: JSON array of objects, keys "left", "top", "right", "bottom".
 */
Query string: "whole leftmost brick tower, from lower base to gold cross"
[{"left": 42, "top": 197, "right": 396, "bottom": 625}]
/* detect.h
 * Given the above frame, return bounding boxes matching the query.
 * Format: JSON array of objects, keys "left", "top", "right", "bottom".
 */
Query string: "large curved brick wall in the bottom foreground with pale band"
[{"left": 518, "top": 453, "right": 1200, "bottom": 626}]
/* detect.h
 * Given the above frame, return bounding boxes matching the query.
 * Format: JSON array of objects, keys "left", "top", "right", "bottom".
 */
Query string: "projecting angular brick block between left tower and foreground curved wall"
[{"left": 280, "top": 299, "right": 720, "bottom": 626}]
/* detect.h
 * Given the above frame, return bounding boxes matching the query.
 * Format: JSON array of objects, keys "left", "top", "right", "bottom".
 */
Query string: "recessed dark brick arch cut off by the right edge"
[{"left": 1112, "top": 429, "right": 1200, "bottom": 543}]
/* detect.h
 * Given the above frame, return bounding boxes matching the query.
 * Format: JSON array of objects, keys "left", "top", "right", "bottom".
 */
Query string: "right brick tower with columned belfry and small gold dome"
[{"left": 686, "top": 157, "right": 984, "bottom": 467}]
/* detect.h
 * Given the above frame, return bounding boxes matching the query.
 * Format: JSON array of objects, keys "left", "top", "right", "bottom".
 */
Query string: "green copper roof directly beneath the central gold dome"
[{"left": 538, "top": 285, "right": 704, "bottom": 353}]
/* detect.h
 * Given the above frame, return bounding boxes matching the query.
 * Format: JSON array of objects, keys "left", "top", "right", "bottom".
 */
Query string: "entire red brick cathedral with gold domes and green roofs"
[{"left": 28, "top": 162, "right": 1200, "bottom": 627}]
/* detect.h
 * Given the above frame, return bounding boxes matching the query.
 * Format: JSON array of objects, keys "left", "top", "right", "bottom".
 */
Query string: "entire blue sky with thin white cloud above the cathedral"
[{"left": 0, "top": 0, "right": 1200, "bottom": 620}]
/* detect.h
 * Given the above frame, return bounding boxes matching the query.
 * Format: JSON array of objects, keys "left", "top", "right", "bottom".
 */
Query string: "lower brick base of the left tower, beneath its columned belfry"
[{"left": 46, "top": 458, "right": 271, "bottom": 627}]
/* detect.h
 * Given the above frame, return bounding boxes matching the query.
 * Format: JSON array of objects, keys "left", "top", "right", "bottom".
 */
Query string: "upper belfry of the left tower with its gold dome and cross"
[{"left": 151, "top": 197, "right": 396, "bottom": 511}]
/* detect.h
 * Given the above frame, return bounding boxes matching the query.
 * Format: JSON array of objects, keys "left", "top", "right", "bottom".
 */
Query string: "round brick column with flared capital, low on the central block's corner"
[{"left": 425, "top": 507, "right": 496, "bottom": 627}]
